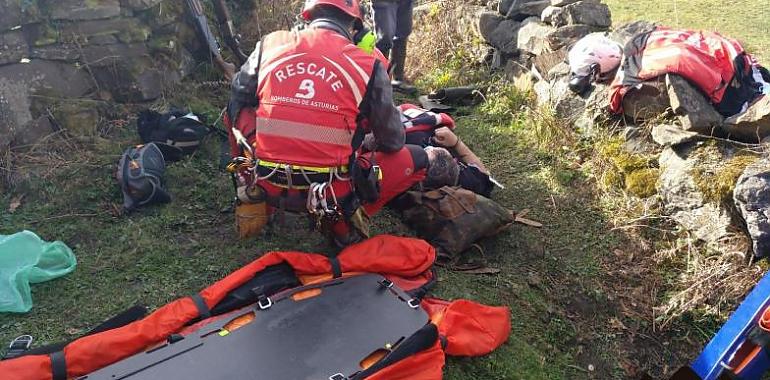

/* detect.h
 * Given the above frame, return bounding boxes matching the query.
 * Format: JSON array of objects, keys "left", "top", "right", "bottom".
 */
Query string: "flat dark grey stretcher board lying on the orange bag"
[{"left": 81, "top": 275, "right": 428, "bottom": 380}]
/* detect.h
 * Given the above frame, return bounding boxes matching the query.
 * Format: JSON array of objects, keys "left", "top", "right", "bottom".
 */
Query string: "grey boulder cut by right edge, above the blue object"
[{"left": 733, "top": 156, "right": 770, "bottom": 258}]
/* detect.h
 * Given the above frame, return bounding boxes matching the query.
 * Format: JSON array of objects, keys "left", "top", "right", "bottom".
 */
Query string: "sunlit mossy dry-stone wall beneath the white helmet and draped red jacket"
[{"left": 468, "top": 0, "right": 770, "bottom": 255}]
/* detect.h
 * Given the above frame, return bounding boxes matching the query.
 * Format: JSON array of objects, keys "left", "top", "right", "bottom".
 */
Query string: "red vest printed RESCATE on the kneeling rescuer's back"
[{"left": 254, "top": 28, "right": 376, "bottom": 167}]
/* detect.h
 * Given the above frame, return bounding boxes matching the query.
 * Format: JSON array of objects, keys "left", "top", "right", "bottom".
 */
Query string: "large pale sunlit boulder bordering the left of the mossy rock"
[{"left": 657, "top": 143, "right": 734, "bottom": 243}]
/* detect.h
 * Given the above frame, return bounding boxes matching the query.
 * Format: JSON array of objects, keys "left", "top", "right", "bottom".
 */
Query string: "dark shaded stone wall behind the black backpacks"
[{"left": 0, "top": 0, "right": 197, "bottom": 149}]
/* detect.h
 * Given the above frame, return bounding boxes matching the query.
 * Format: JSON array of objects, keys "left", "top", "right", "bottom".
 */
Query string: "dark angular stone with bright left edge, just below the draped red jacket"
[{"left": 666, "top": 74, "right": 724, "bottom": 135}]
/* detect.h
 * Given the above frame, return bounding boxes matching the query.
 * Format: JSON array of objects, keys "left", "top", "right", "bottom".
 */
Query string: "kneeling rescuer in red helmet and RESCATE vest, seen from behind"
[{"left": 226, "top": 0, "right": 427, "bottom": 246}]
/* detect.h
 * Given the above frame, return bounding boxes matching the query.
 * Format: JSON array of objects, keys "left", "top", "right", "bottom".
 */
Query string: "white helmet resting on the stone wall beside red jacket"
[{"left": 568, "top": 33, "right": 623, "bottom": 77}]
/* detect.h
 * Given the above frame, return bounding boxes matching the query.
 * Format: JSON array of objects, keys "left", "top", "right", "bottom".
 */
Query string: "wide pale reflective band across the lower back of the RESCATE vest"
[{"left": 256, "top": 117, "right": 353, "bottom": 147}]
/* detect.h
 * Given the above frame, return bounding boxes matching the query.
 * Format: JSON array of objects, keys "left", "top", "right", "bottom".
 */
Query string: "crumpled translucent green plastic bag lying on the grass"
[{"left": 0, "top": 231, "right": 77, "bottom": 313}]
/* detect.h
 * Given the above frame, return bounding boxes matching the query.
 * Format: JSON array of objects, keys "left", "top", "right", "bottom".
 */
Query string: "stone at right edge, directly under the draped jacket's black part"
[{"left": 722, "top": 95, "right": 770, "bottom": 143}]
